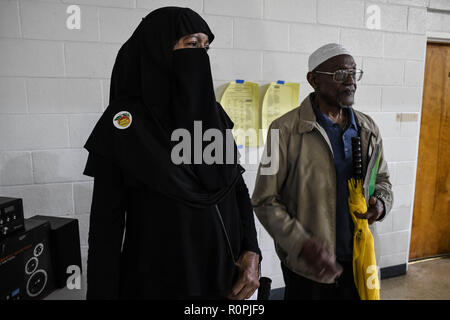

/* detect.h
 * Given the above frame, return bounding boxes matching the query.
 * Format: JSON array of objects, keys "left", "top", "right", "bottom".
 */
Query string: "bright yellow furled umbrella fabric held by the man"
[{"left": 348, "top": 178, "right": 380, "bottom": 300}]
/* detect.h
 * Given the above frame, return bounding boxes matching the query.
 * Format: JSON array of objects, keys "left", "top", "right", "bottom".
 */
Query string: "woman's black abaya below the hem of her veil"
[{"left": 87, "top": 149, "right": 260, "bottom": 299}]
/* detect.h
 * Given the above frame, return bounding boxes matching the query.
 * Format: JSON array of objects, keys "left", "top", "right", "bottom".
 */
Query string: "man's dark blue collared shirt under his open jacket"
[{"left": 311, "top": 96, "right": 358, "bottom": 261}]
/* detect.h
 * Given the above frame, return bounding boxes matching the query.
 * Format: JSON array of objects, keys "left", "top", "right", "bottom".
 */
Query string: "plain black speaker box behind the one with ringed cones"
[{"left": 33, "top": 215, "right": 82, "bottom": 288}]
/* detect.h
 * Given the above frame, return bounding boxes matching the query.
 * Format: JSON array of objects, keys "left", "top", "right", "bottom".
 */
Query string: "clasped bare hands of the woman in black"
[{"left": 228, "top": 251, "right": 259, "bottom": 300}]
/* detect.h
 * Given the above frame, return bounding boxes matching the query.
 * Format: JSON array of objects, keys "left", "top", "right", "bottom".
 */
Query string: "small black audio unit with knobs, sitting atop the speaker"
[{"left": 0, "top": 197, "right": 24, "bottom": 240}]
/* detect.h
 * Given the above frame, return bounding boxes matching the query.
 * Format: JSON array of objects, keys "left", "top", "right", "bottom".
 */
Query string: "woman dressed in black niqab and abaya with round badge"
[{"left": 84, "top": 7, "right": 260, "bottom": 299}]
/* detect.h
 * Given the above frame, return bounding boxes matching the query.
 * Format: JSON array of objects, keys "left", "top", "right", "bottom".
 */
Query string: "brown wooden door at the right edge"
[{"left": 409, "top": 43, "right": 450, "bottom": 259}]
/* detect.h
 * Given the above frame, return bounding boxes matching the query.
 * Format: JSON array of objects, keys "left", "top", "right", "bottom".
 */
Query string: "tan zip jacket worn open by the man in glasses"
[{"left": 252, "top": 96, "right": 393, "bottom": 283}]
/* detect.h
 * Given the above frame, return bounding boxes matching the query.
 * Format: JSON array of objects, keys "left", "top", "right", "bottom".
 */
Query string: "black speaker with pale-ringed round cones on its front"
[{"left": 0, "top": 219, "right": 54, "bottom": 300}]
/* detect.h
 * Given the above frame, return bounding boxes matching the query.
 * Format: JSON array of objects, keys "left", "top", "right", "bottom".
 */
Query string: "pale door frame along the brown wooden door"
[{"left": 406, "top": 31, "right": 450, "bottom": 271}]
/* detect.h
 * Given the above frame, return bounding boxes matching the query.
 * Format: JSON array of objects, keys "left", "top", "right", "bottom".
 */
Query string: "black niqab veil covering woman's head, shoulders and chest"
[{"left": 85, "top": 7, "right": 242, "bottom": 207}]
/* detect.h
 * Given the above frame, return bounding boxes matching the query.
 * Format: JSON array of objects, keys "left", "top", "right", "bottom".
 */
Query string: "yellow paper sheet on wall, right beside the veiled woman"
[{"left": 220, "top": 80, "right": 259, "bottom": 148}]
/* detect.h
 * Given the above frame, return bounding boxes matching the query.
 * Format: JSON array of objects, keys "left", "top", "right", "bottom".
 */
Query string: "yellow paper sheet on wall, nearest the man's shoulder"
[{"left": 261, "top": 81, "right": 300, "bottom": 142}]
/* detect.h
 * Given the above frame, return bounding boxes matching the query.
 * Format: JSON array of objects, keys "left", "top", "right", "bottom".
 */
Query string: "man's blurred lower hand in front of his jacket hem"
[{"left": 300, "top": 237, "right": 343, "bottom": 279}]
